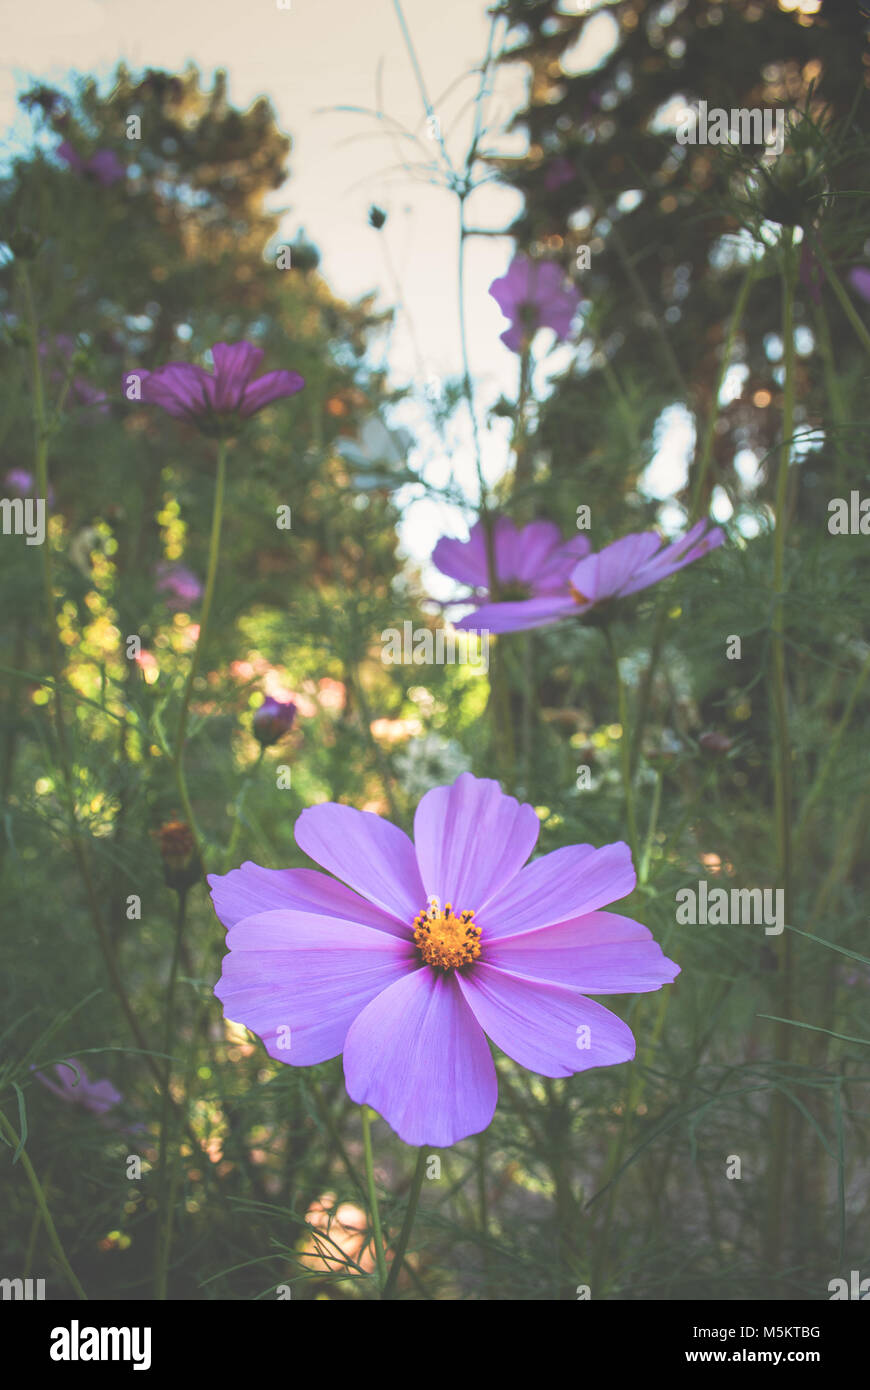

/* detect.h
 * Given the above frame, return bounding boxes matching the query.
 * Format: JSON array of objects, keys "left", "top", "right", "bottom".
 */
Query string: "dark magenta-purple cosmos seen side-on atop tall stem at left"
[{"left": 124, "top": 342, "right": 304, "bottom": 434}]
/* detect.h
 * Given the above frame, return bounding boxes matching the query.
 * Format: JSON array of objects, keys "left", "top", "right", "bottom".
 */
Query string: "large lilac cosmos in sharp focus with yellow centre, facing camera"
[{"left": 208, "top": 773, "right": 680, "bottom": 1148}]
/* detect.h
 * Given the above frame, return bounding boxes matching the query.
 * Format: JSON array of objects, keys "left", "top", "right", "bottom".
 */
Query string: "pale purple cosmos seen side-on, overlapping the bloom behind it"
[{"left": 456, "top": 520, "right": 724, "bottom": 632}]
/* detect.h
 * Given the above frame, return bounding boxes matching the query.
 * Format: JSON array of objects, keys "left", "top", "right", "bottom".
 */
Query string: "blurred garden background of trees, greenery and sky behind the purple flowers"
[{"left": 0, "top": 0, "right": 870, "bottom": 1300}]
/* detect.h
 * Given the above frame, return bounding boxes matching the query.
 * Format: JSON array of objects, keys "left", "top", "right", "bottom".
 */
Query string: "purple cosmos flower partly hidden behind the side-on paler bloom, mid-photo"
[{"left": 432, "top": 517, "right": 589, "bottom": 614}]
